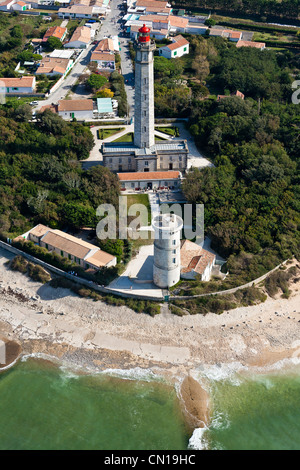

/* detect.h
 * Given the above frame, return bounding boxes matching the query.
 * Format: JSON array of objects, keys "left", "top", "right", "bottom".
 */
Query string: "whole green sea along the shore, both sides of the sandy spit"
[{"left": 0, "top": 357, "right": 300, "bottom": 451}]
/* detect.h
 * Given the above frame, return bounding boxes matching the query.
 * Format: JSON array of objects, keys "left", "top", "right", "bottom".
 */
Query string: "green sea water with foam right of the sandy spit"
[{"left": 194, "top": 367, "right": 300, "bottom": 450}]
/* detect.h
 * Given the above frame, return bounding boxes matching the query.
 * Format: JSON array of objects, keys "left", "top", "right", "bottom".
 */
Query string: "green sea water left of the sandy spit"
[{"left": 0, "top": 360, "right": 189, "bottom": 450}]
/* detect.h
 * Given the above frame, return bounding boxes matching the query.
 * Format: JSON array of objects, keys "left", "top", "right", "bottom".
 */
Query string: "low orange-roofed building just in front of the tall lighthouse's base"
[{"left": 117, "top": 171, "right": 182, "bottom": 191}]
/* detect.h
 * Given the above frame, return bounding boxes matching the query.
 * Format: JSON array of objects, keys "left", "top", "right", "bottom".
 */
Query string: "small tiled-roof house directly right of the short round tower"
[{"left": 180, "top": 240, "right": 216, "bottom": 281}]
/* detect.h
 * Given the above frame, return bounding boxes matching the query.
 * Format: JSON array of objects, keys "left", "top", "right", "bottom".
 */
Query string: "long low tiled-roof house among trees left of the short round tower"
[{"left": 18, "top": 224, "right": 117, "bottom": 270}]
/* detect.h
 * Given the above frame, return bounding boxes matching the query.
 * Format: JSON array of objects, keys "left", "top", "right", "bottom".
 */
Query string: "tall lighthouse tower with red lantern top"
[{"left": 134, "top": 25, "right": 155, "bottom": 149}]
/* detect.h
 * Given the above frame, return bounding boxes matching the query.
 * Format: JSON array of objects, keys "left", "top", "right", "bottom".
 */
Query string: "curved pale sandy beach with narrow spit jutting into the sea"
[{"left": 0, "top": 250, "right": 300, "bottom": 424}]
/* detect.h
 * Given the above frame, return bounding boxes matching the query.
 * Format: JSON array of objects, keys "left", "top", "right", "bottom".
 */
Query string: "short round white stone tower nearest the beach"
[{"left": 152, "top": 214, "right": 183, "bottom": 289}]
